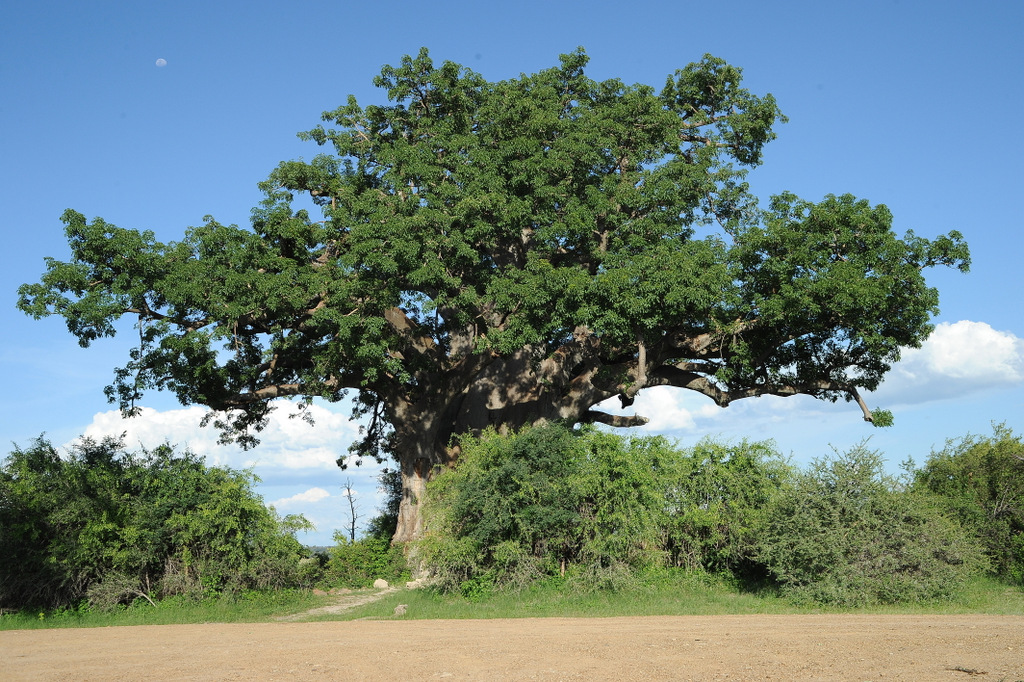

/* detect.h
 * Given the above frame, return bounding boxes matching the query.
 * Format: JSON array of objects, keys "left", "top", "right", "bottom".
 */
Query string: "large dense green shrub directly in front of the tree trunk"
[{"left": 418, "top": 425, "right": 688, "bottom": 589}]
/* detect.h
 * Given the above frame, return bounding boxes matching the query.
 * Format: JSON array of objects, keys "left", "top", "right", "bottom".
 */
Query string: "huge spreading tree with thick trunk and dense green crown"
[{"left": 18, "top": 49, "right": 969, "bottom": 541}]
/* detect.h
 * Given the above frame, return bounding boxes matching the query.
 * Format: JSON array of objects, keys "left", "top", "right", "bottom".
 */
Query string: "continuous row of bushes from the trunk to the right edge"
[{"left": 419, "top": 425, "right": 1024, "bottom": 606}]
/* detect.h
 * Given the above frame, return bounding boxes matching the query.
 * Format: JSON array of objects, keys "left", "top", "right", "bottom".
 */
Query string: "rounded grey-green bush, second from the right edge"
[{"left": 759, "top": 445, "right": 984, "bottom": 605}]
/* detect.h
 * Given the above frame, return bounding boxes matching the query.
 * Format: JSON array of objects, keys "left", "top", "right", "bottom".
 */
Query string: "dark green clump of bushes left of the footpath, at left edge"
[{"left": 0, "top": 437, "right": 310, "bottom": 607}]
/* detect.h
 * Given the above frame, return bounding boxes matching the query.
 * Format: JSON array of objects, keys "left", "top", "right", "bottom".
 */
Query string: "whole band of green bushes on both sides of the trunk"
[{"left": 6, "top": 425, "right": 1024, "bottom": 610}]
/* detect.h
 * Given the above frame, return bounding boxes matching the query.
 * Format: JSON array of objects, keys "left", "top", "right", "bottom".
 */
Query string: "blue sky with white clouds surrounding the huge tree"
[{"left": 0, "top": 0, "right": 1024, "bottom": 544}]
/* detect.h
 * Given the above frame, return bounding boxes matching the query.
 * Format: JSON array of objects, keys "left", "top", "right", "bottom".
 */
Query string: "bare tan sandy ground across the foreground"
[{"left": 0, "top": 615, "right": 1024, "bottom": 682}]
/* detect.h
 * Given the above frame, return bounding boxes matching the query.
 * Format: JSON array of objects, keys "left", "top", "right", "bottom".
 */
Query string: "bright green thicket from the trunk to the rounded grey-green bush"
[{"left": 420, "top": 425, "right": 788, "bottom": 594}]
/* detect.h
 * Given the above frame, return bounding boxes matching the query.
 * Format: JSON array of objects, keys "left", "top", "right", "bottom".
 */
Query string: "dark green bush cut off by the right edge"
[{"left": 913, "top": 425, "right": 1024, "bottom": 585}]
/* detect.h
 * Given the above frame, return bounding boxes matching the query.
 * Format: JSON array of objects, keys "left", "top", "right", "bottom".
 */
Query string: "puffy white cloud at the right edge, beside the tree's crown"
[{"left": 877, "top": 319, "right": 1024, "bottom": 403}]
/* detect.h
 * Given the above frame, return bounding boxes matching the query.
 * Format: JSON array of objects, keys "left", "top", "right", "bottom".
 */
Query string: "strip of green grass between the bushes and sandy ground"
[{"left": 0, "top": 573, "right": 1024, "bottom": 630}]
